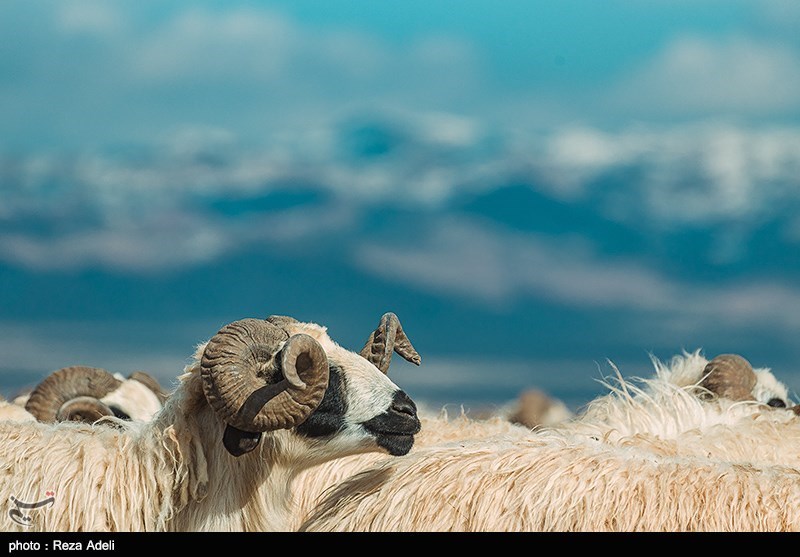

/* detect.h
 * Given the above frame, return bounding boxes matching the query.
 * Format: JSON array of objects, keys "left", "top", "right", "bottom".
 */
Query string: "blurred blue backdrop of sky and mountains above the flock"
[{"left": 0, "top": 0, "right": 800, "bottom": 409}]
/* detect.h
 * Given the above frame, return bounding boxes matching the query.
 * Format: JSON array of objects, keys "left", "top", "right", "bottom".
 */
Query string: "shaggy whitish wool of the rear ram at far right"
[{"left": 545, "top": 353, "right": 800, "bottom": 468}]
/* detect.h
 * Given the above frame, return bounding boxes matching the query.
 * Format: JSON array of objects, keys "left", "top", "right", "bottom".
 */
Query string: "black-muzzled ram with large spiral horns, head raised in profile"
[{"left": 0, "top": 310, "right": 420, "bottom": 531}]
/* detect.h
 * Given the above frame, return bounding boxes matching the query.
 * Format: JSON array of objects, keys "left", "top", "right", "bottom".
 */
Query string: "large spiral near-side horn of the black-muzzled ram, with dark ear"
[{"left": 200, "top": 319, "right": 329, "bottom": 456}]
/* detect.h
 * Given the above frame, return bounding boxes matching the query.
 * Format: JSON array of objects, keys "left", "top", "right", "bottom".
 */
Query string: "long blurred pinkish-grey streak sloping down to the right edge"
[{"left": 356, "top": 215, "right": 800, "bottom": 329}]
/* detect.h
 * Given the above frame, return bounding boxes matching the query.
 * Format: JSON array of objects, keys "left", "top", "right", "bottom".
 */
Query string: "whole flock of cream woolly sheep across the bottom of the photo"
[{"left": 0, "top": 313, "right": 800, "bottom": 532}]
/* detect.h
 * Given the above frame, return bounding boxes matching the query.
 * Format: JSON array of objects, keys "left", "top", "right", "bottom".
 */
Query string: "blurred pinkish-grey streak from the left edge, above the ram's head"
[{"left": 0, "top": 198, "right": 353, "bottom": 274}]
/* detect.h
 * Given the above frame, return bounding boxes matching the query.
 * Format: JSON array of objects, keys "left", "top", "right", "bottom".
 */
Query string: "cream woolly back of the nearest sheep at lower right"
[{"left": 300, "top": 433, "right": 800, "bottom": 532}]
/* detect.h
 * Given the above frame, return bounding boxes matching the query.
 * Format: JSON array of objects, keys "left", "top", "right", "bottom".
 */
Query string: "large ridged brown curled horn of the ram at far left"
[{"left": 25, "top": 366, "right": 122, "bottom": 422}]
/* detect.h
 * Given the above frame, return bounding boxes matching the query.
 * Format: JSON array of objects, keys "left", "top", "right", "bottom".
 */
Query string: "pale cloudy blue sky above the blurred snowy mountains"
[{"left": 6, "top": 0, "right": 800, "bottom": 149}]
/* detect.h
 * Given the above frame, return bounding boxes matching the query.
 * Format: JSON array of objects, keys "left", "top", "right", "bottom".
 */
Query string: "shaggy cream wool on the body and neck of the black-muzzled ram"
[{"left": 0, "top": 374, "right": 212, "bottom": 531}]
